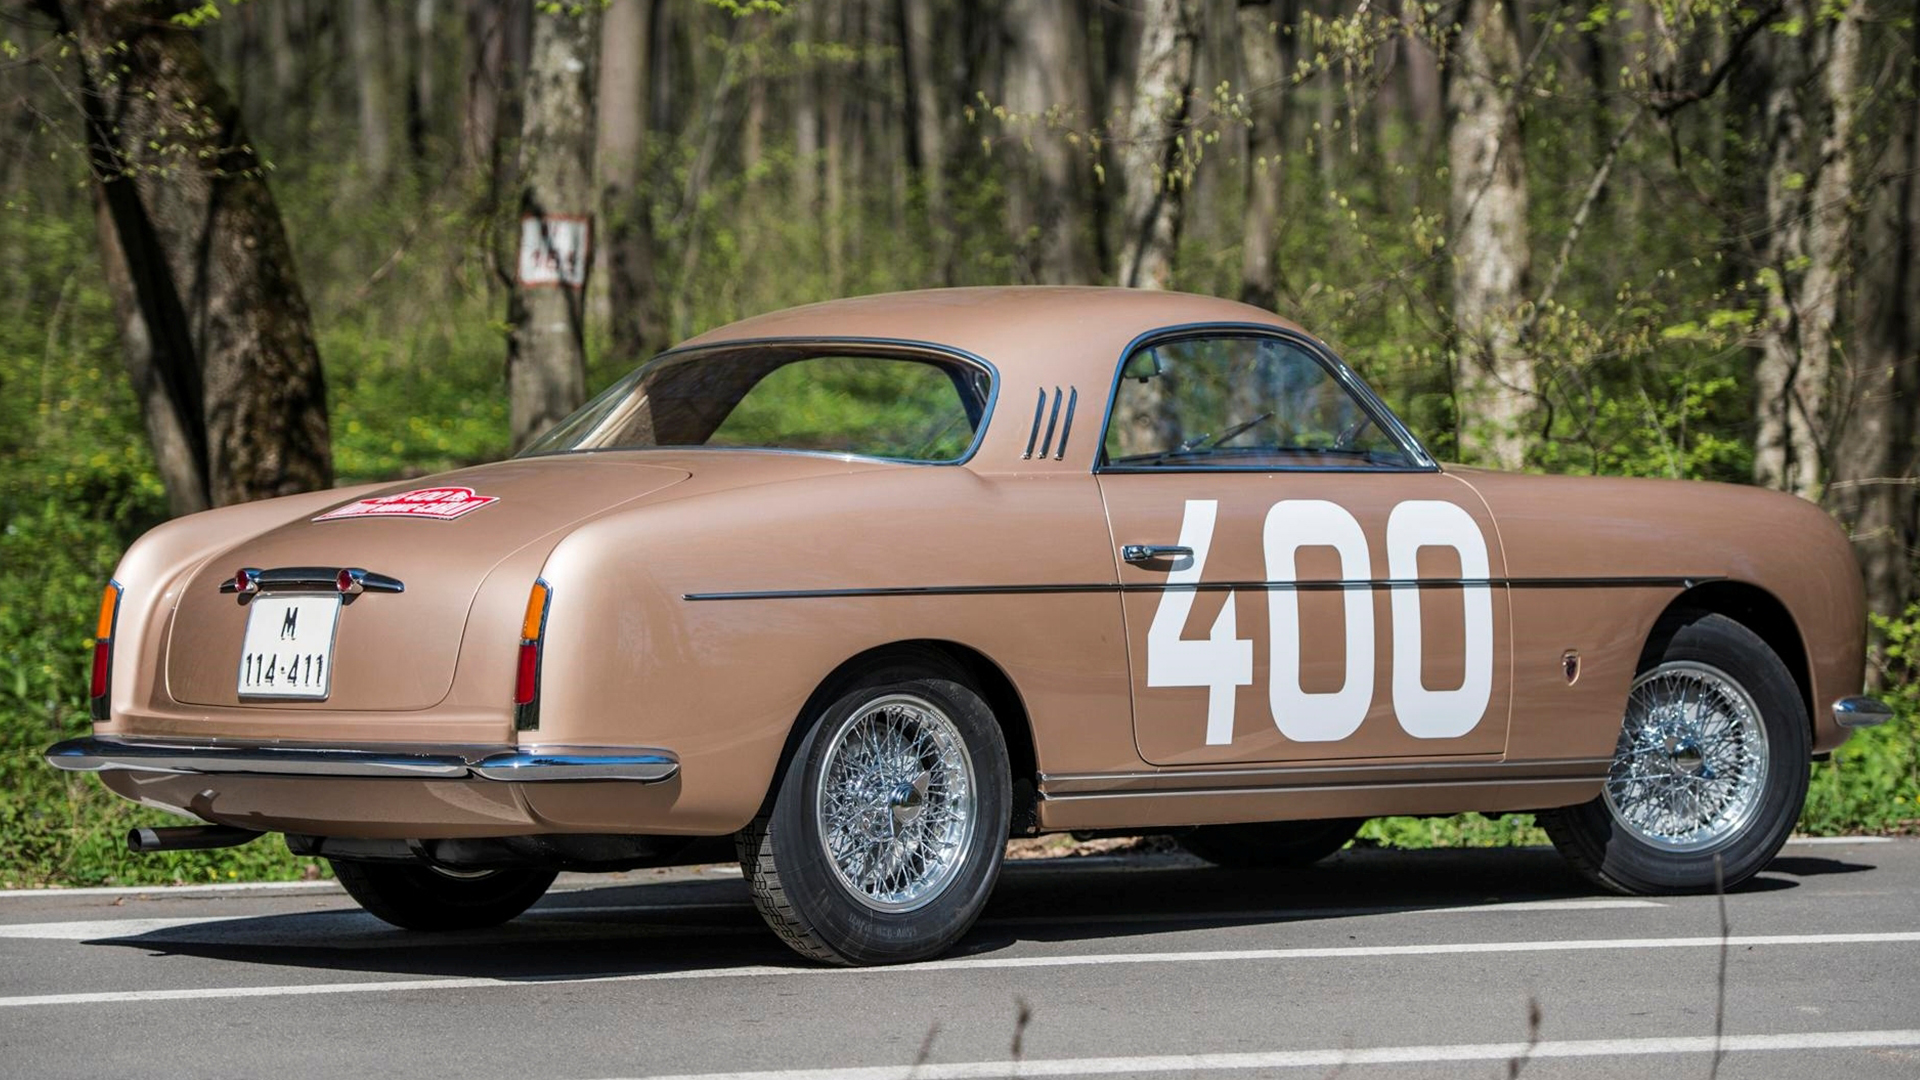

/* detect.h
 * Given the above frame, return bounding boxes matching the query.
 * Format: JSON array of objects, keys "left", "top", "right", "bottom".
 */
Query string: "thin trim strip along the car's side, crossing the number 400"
[{"left": 682, "top": 575, "right": 1726, "bottom": 601}]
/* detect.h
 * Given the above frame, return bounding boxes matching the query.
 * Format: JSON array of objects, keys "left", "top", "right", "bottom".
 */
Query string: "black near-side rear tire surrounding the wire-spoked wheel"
[{"left": 768, "top": 673, "right": 1012, "bottom": 965}]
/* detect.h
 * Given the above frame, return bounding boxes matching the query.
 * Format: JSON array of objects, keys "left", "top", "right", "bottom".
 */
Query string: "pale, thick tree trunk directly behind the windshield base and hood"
[{"left": 1446, "top": 0, "right": 1534, "bottom": 469}]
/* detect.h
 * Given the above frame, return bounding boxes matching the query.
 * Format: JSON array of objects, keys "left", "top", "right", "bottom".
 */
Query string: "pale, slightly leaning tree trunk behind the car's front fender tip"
[{"left": 1753, "top": 0, "right": 1860, "bottom": 500}]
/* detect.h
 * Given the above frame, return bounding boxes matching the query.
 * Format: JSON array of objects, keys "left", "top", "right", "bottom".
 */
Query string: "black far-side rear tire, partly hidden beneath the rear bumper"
[{"left": 330, "top": 859, "right": 557, "bottom": 932}]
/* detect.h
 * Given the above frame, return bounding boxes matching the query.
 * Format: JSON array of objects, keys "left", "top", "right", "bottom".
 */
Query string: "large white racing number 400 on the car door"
[{"left": 1146, "top": 500, "right": 1494, "bottom": 746}]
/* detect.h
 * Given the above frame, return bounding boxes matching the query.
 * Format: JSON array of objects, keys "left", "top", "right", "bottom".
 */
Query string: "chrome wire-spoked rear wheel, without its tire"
[{"left": 814, "top": 694, "right": 975, "bottom": 911}]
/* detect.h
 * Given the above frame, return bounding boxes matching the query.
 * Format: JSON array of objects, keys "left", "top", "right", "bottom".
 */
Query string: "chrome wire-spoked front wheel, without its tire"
[{"left": 1605, "top": 661, "right": 1768, "bottom": 851}]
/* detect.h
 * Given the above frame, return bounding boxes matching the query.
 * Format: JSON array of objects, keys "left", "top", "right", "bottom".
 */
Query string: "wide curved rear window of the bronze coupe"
[{"left": 522, "top": 346, "right": 993, "bottom": 463}]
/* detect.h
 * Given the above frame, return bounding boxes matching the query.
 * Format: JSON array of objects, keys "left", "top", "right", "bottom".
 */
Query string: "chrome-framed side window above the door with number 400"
[{"left": 1102, "top": 336, "right": 1413, "bottom": 469}]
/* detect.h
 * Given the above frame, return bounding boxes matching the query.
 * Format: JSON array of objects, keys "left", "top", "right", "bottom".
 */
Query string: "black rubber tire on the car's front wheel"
[{"left": 1538, "top": 615, "right": 1812, "bottom": 896}]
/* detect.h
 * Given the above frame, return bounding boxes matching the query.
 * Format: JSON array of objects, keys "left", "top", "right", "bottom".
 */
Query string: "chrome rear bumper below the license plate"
[{"left": 46, "top": 736, "right": 680, "bottom": 784}]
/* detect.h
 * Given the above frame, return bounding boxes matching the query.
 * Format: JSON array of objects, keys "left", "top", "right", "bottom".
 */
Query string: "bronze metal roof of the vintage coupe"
[{"left": 680, "top": 284, "right": 1304, "bottom": 380}]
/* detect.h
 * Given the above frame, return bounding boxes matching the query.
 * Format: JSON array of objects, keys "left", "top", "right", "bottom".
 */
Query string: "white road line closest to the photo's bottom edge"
[{"left": 595, "top": 1028, "right": 1920, "bottom": 1080}]
